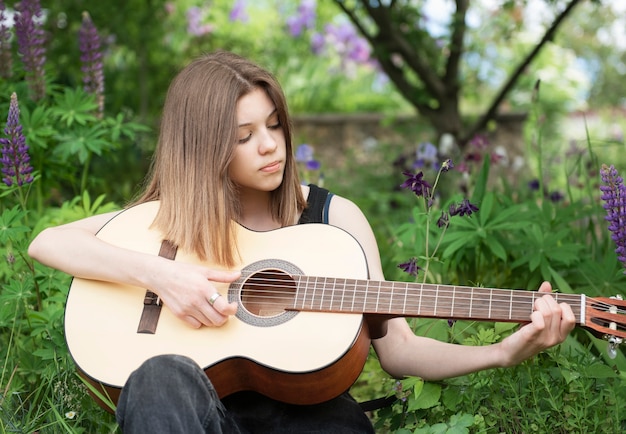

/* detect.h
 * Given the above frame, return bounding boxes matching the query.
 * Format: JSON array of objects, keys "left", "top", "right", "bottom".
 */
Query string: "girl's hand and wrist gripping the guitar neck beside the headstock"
[{"left": 500, "top": 282, "right": 576, "bottom": 366}]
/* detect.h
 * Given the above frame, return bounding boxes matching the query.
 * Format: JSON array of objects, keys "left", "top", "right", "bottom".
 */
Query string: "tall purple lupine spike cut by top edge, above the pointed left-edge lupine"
[{"left": 15, "top": 0, "right": 46, "bottom": 101}]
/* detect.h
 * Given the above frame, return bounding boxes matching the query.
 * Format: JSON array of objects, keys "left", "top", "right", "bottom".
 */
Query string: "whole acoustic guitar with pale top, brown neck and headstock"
[{"left": 65, "top": 202, "right": 626, "bottom": 411}]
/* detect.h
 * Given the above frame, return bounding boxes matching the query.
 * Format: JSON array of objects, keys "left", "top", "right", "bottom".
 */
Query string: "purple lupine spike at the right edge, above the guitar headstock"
[{"left": 600, "top": 164, "right": 626, "bottom": 274}]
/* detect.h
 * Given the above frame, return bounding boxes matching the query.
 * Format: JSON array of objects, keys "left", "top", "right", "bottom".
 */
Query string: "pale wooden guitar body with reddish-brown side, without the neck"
[{"left": 65, "top": 202, "right": 370, "bottom": 410}]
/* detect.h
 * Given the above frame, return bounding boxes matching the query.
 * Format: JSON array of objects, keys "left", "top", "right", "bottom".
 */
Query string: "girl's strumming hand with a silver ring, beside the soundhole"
[{"left": 152, "top": 260, "right": 241, "bottom": 328}]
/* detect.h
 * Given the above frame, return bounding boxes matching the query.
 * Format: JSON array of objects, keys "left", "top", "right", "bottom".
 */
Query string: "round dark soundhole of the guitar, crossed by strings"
[{"left": 241, "top": 270, "right": 296, "bottom": 317}]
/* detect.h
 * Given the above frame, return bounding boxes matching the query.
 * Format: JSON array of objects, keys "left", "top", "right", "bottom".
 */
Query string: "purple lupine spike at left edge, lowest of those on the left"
[{"left": 0, "top": 92, "right": 33, "bottom": 187}]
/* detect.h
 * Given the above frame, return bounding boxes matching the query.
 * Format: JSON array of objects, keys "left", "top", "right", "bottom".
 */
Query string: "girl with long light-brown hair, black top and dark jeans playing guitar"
[{"left": 29, "top": 52, "right": 575, "bottom": 433}]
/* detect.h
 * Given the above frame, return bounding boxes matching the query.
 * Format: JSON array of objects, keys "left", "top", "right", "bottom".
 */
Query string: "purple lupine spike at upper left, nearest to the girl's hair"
[{"left": 78, "top": 12, "right": 104, "bottom": 116}]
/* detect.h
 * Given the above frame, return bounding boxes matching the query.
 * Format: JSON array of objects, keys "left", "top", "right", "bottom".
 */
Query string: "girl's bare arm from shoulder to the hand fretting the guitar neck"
[{"left": 329, "top": 196, "right": 576, "bottom": 380}]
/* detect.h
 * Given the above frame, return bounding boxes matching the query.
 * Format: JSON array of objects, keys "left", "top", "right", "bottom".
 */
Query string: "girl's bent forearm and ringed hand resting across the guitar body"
[{"left": 28, "top": 212, "right": 240, "bottom": 327}]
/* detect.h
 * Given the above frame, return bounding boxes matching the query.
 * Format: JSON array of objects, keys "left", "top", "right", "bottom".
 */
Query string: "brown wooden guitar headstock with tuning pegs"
[{"left": 584, "top": 296, "right": 626, "bottom": 359}]
